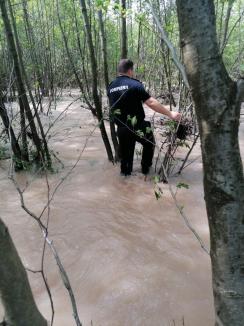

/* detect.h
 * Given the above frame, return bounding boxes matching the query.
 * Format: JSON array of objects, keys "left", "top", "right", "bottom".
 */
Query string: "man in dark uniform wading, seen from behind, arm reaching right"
[{"left": 108, "top": 59, "right": 181, "bottom": 176}]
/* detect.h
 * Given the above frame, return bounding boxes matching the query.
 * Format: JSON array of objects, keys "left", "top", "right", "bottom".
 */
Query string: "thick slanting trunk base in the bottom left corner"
[{"left": 0, "top": 219, "right": 47, "bottom": 326}]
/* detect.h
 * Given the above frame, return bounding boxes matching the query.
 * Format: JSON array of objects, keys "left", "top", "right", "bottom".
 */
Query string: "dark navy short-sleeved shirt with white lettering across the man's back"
[{"left": 107, "top": 75, "right": 150, "bottom": 127}]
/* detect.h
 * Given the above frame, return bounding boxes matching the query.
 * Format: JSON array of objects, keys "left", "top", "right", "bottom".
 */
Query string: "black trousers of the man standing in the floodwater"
[{"left": 117, "top": 121, "right": 155, "bottom": 175}]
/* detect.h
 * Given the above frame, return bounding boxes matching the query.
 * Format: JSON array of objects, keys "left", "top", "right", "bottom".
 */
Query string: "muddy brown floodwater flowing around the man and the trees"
[{"left": 0, "top": 93, "right": 244, "bottom": 326}]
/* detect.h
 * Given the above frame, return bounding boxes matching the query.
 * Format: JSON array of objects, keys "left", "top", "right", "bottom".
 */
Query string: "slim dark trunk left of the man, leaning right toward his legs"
[{"left": 80, "top": 0, "right": 114, "bottom": 162}]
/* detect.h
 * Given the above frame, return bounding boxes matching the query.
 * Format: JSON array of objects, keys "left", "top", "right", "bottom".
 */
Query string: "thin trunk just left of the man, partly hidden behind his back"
[{"left": 98, "top": 10, "right": 119, "bottom": 162}]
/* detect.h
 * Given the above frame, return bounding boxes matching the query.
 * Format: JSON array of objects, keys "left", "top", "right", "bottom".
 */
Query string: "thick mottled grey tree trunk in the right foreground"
[{"left": 177, "top": 0, "right": 244, "bottom": 326}]
